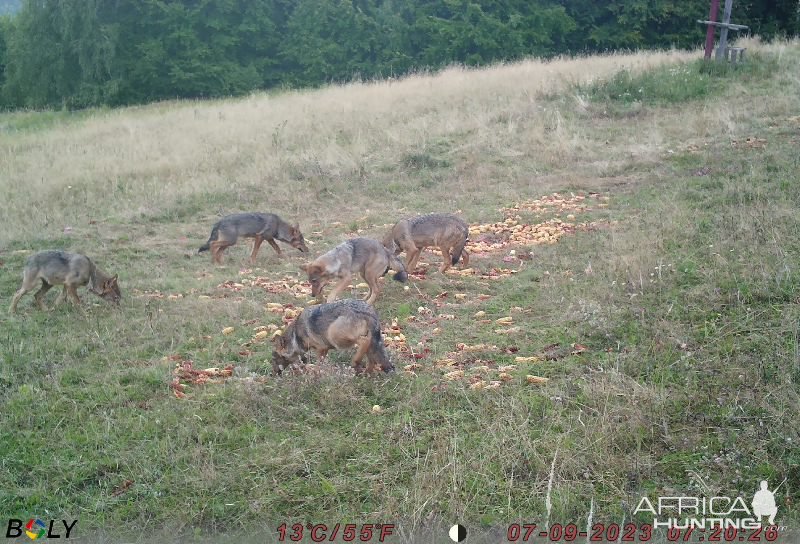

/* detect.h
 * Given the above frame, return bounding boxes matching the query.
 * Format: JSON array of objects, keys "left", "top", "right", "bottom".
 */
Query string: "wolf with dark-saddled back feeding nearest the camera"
[{"left": 272, "top": 299, "right": 394, "bottom": 375}]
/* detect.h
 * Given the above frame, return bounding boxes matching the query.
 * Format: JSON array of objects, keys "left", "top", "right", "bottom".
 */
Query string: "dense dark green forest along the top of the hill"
[{"left": 0, "top": 0, "right": 800, "bottom": 109}]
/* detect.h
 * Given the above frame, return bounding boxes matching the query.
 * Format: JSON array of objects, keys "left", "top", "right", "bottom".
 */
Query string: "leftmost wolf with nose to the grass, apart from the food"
[{"left": 9, "top": 250, "right": 122, "bottom": 314}]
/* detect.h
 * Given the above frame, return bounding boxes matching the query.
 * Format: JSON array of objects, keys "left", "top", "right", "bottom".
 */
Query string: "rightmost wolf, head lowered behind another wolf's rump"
[{"left": 383, "top": 213, "right": 469, "bottom": 273}]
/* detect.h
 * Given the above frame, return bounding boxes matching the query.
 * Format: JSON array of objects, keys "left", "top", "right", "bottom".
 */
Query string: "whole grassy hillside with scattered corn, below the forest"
[{"left": 0, "top": 42, "right": 800, "bottom": 542}]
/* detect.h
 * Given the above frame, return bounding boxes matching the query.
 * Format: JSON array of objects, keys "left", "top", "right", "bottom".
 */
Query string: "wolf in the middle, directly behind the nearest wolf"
[{"left": 300, "top": 238, "right": 408, "bottom": 304}]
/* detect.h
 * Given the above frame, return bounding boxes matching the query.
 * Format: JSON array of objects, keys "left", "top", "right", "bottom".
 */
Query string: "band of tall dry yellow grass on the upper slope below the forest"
[{"left": 0, "top": 46, "right": 712, "bottom": 246}]
